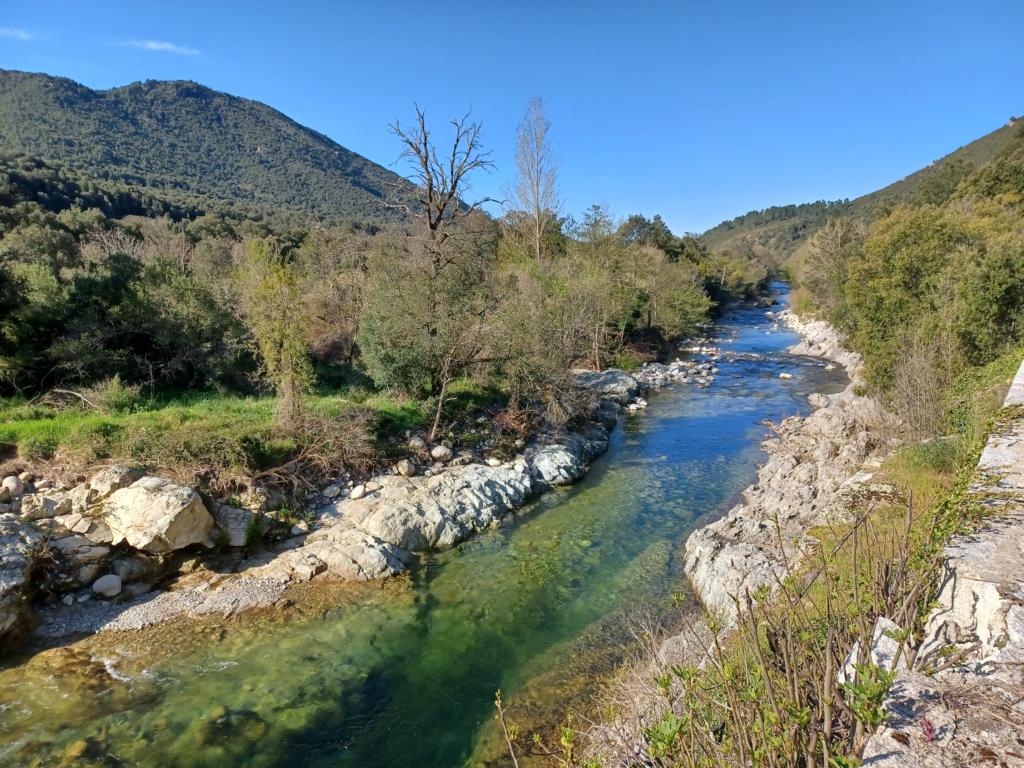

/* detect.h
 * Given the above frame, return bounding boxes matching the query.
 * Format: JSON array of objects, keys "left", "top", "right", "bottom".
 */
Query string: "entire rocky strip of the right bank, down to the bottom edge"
[{"left": 586, "top": 310, "right": 898, "bottom": 764}]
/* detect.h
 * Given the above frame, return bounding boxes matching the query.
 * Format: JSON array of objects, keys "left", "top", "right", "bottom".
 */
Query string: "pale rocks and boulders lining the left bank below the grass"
[{"left": 0, "top": 370, "right": 640, "bottom": 638}]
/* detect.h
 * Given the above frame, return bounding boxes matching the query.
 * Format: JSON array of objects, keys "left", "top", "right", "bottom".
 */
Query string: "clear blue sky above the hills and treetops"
[{"left": 0, "top": 0, "right": 1024, "bottom": 231}]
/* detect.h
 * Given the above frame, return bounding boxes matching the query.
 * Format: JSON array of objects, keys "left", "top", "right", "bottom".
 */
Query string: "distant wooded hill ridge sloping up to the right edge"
[{"left": 700, "top": 118, "right": 1024, "bottom": 264}]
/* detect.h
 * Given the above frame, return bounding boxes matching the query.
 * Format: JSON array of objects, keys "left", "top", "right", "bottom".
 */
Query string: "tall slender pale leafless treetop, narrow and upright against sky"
[{"left": 512, "top": 96, "right": 559, "bottom": 261}]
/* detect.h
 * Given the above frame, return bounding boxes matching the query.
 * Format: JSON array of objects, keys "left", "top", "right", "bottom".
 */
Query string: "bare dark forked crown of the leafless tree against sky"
[{"left": 391, "top": 104, "right": 499, "bottom": 245}]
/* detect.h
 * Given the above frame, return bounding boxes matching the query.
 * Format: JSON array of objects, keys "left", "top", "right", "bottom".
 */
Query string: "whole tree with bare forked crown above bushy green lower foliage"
[{"left": 358, "top": 105, "right": 498, "bottom": 441}]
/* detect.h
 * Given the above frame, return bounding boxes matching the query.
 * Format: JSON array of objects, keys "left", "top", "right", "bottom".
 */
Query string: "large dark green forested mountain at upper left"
[{"left": 0, "top": 70, "right": 411, "bottom": 222}]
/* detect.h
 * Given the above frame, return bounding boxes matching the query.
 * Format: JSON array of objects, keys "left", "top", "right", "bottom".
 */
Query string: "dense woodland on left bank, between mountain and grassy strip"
[{"left": 0, "top": 96, "right": 768, "bottom": 481}]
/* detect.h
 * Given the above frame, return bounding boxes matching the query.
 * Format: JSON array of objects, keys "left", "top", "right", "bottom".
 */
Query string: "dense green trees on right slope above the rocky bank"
[{"left": 795, "top": 126, "right": 1024, "bottom": 436}]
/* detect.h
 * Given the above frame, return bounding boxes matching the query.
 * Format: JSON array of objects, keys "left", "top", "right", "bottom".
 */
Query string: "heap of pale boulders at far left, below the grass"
[{"left": 0, "top": 465, "right": 272, "bottom": 637}]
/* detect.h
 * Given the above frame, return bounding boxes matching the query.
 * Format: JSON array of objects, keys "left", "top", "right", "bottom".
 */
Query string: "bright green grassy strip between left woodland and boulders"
[{"left": 0, "top": 381, "right": 507, "bottom": 495}]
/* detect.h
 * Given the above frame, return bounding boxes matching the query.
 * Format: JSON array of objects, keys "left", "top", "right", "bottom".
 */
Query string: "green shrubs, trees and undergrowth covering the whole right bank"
[{"left": 498, "top": 121, "right": 1024, "bottom": 767}]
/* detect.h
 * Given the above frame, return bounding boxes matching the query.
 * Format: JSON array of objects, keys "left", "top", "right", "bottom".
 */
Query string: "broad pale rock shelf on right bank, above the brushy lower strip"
[{"left": 684, "top": 310, "right": 897, "bottom": 625}]
